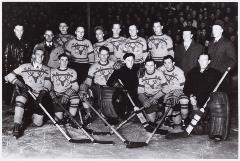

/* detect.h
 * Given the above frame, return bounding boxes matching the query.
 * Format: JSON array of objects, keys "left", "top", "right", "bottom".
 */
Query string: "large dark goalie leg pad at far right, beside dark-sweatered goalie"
[{"left": 208, "top": 92, "right": 229, "bottom": 140}]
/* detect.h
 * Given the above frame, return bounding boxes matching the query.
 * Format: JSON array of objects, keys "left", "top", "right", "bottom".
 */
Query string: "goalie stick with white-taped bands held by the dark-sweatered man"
[{"left": 185, "top": 67, "right": 231, "bottom": 135}]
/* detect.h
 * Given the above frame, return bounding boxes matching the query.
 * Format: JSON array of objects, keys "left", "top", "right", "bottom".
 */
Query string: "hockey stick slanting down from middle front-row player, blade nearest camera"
[{"left": 84, "top": 100, "right": 147, "bottom": 148}]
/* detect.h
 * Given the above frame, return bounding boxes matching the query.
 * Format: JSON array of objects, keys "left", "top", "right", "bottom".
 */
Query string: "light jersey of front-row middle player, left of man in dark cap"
[{"left": 85, "top": 61, "right": 114, "bottom": 86}]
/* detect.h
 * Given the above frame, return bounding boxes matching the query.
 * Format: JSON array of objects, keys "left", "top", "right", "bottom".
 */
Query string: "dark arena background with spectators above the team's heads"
[{"left": 2, "top": 2, "right": 238, "bottom": 48}]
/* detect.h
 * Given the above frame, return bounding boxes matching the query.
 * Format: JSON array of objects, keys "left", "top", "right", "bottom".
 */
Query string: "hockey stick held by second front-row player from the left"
[{"left": 54, "top": 102, "right": 114, "bottom": 144}]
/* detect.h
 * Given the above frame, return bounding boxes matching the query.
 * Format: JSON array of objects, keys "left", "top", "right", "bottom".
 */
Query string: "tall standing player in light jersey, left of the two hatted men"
[{"left": 148, "top": 20, "right": 174, "bottom": 68}]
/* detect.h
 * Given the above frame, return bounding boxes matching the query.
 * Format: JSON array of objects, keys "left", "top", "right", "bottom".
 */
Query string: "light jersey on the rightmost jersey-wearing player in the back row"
[{"left": 148, "top": 34, "right": 174, "bottom": 62}]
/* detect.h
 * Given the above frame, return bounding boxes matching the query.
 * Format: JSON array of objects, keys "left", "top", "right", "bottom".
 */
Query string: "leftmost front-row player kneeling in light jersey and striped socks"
[{"left": 5, "top": 48, "right": 51, "bottom": 137}]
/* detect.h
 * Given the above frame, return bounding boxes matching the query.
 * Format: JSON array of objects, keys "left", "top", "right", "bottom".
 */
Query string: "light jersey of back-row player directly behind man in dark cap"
[{"left": 123, "top": 37, "right": 148, "bottom": 64}]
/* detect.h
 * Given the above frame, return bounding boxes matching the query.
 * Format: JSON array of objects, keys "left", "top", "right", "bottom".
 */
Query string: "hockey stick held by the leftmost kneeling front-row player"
[{"left": 28, "top": 90, "right": 92, "bottom": 143}]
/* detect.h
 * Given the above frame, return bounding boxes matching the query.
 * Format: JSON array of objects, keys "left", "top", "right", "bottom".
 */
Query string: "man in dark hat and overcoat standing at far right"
[{"left": 208, "top": 20, "right": 237, "bottom": 73}]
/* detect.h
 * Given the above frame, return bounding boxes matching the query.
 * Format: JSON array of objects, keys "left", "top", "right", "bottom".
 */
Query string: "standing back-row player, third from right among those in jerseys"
[{"left": 107, "top": 23, "right": 126, "bottom": 63}]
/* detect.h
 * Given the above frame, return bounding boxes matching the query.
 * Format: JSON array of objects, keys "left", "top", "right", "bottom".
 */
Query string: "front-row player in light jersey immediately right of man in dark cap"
[{"left": 138, "top": 58, "right": 168, "bottom": 122}]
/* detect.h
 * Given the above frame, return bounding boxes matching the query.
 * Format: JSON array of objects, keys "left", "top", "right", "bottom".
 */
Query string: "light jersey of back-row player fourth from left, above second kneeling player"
[{"left": 65, "top": 38, "right": 93, "bottom": 63}]
